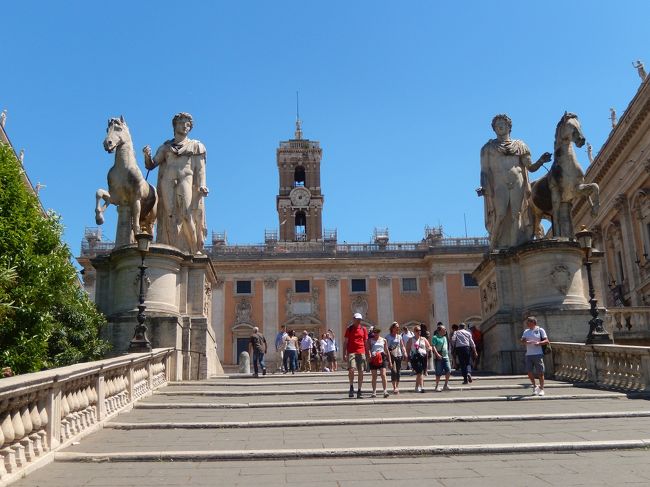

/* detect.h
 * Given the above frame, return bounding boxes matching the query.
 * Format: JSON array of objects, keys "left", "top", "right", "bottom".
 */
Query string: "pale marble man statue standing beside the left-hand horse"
[{"left": 143, "top": 113, "right": 208, "bottom": 254}]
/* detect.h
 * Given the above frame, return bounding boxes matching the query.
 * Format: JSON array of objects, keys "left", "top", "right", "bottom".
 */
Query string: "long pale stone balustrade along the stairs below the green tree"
[{"left": 0, "top": 349, "right": 176, "bottom": 486}]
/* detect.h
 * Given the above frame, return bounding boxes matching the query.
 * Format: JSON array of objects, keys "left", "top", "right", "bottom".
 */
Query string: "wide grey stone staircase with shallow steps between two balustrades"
[{"left": 14, "top": 373, "right": 650, "bottom": 487}]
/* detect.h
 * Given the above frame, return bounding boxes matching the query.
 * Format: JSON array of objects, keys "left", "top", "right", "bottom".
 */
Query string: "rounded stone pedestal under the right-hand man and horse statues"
[{"left": 474, "top": 238, "right": 604, "bottom": 374}]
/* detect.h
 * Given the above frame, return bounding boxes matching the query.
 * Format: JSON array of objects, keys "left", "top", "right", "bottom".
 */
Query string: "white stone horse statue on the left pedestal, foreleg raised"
[{"left": 95, "top": 117, "right": 158, "bottom": 247}]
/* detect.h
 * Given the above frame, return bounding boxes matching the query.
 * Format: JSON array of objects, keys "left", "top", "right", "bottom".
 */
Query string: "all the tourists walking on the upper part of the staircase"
[{"left": 250, "top": 313, "right": 549, "bottom": 398}]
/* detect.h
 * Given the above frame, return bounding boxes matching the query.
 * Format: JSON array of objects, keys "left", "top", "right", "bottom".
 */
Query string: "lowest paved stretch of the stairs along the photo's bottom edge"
[{"left": 13, "top": 450, "right": 650, "bottom": 487}]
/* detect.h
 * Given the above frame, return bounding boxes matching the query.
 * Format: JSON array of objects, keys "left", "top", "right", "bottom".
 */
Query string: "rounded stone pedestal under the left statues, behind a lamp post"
[{"left": 92, "top": 244, "right": 223, "bottom": 379}]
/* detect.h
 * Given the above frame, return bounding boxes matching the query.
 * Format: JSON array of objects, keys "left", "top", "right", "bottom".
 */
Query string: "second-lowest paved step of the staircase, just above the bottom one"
[{"left": 57, "top": 417, "right": 650, "bottom": 453}]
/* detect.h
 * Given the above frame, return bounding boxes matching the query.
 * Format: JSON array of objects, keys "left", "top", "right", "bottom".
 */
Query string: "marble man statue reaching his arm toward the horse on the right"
[{"left": 477, "top": 115, "right": 551, "bottom": 249}]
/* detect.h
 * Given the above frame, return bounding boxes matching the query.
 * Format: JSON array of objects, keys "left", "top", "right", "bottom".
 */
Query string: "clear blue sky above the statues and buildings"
[{"left": 0, "top": 0, "right": 650, "bottom": 255}]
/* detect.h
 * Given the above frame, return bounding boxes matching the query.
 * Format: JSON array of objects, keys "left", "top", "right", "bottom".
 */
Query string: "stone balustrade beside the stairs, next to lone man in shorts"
[{"left": 552, "top": 342, "right": 650, "bottom": 391}]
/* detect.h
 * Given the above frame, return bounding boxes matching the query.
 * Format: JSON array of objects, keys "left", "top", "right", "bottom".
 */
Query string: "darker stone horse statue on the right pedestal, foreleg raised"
[{"left": 530, "top": 112, "right": 600, "bottom": 238}]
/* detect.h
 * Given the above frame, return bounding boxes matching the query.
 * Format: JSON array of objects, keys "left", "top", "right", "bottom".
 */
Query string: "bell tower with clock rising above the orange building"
[{"left": 276, "top": 118, "right": 323, "bottom": 242}]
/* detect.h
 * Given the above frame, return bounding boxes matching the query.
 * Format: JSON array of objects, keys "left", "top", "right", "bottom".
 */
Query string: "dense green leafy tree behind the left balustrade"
[{"left": 0, "top": 144, "right": 109, "bottom": 373}]
